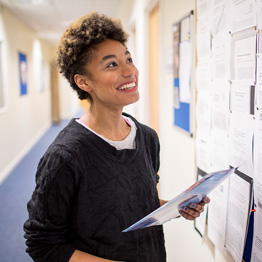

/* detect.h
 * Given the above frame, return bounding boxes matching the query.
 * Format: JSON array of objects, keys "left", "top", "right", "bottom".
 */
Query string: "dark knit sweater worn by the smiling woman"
[{"left": 24, "top": 114, "right": 166, "bottom": 262}]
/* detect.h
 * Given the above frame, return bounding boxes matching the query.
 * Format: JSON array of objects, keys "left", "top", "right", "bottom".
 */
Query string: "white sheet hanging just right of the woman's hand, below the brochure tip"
[{"left": 207, "top": 179, "right": 229, "bottom": 252}]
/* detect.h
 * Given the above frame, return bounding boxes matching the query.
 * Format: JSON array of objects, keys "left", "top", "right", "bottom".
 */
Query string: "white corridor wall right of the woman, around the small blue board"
[{"left": 126, "top": 0, "right": 233, "bottom": 262}]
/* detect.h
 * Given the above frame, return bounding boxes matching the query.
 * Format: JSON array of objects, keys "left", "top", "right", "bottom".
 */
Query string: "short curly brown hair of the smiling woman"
[{"left": 57, "top": 12, "right": 128, "bottom": 102}]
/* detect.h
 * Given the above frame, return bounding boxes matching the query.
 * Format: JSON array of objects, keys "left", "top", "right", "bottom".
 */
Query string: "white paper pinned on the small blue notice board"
[{"left": 179, "top": 41, "right": 192, "bottom": 103}]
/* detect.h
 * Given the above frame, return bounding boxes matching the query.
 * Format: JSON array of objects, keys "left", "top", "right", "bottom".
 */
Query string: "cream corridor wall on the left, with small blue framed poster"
[{"left": 0, "top": 5, "right": 78, "bottom": 184}]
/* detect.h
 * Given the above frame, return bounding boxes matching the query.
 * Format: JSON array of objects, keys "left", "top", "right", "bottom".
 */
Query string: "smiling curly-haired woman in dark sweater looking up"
[{"left": 24, "top": 13, "right": 209, "bottom": 262}]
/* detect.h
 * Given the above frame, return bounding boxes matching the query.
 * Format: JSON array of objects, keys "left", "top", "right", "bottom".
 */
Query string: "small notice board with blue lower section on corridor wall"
[{"left": 173, "top": 11, "right": 194, "bottom": 135}]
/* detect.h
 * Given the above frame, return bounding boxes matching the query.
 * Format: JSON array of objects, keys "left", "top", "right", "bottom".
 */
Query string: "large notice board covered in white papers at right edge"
[{"left": 195, "top": 0, "right": 262, "bottom": 262}]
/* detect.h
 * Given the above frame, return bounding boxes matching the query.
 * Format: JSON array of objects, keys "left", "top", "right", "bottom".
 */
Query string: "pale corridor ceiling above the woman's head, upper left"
[{"left": 0, "top": 0, "right": 128, "bottom": 44}]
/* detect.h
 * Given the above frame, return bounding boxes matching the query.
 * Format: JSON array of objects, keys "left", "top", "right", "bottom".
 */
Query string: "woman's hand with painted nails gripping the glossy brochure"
[{"left": 179, "top": 196, "right": 210, "bottom": 220}]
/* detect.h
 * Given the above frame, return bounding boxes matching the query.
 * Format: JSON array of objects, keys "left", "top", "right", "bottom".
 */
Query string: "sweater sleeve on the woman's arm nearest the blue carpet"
[{"left": 24, "top": 147, "right": 76, "bottom": 262}]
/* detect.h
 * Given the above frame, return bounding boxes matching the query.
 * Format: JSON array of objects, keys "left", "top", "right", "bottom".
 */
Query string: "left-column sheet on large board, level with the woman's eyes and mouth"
[{"left": 196, "top": 56, "right": 212, "bottom": 92}]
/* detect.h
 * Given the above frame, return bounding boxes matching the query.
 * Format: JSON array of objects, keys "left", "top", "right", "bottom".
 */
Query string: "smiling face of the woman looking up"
[{"left": 87, "top": 39, "right": 139, "bottom": 109}]
